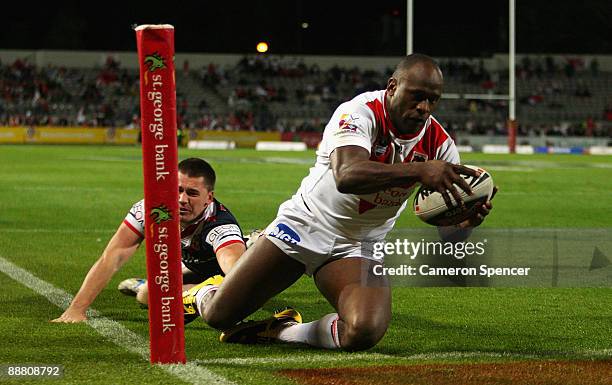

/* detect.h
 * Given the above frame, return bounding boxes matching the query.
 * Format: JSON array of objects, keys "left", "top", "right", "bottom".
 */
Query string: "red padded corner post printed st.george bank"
[{"left": 134, "top": 24, "right": 185, "bottom": 363}]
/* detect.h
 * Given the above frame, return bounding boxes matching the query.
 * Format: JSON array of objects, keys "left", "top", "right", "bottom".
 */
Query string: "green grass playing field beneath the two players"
[{"left": 0, "top": 146, "right": 612, "bottom": 385}]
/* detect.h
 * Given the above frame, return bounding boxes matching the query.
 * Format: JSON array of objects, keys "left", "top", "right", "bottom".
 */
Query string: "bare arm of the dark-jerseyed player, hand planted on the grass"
[{"left": 52, "top": 223, "right": 142, "bottom": 322}]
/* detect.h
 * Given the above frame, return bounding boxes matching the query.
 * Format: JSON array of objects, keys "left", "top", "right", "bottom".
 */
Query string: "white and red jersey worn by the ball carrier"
[{"left": 286, "top": 90, "right": 459, "bottom": 240}]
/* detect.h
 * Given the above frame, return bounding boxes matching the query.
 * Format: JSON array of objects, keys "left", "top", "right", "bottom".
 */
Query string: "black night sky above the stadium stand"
[{"left": 0, "top": 0, "right": 612, "bottom": 56}]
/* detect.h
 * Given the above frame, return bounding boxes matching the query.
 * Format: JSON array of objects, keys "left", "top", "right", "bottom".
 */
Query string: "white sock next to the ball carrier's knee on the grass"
[{"left": 277, "top": 313, "right": 340, "bottom": 349}]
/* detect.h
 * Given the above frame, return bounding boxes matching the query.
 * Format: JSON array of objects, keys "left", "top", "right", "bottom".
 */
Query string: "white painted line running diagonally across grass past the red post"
[{"left": 0, "top": 256, "right": 235, "bottom": 385}]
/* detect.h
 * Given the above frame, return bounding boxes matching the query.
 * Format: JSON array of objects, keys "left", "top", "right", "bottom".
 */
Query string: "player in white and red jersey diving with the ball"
[{"left": 183, "top": 54, "right": 492, "bottom": 350}]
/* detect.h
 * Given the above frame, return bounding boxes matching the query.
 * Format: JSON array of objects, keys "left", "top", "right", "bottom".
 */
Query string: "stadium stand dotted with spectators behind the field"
[{"left": 0, "top": 56, "right": 612, "bottom": 137}]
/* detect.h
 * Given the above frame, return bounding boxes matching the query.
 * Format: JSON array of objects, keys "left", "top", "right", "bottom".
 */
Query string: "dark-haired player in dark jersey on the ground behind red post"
[{"left": 53, "top": 158, "right": 245, "bottom": 322}]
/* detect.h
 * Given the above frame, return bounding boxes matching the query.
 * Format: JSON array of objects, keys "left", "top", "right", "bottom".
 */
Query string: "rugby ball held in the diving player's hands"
[{"left": 413, "top": 165, "right": 495, "bottom": 226}]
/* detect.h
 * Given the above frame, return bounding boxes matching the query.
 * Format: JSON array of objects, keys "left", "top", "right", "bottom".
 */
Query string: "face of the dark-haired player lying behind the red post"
[{"left": 179, "top": 172, "right": 214, "bottom": 224}]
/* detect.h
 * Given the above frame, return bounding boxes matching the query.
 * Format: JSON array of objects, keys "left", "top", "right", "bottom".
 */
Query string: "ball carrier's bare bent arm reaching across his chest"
[{"left": 331, "top": 146, "right": 478, "bottom": 207}]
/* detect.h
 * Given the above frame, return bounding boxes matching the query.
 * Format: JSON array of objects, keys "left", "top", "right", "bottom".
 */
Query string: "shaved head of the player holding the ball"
[{"left": 387, "top": 63, "right": 443, "bottom": 134}]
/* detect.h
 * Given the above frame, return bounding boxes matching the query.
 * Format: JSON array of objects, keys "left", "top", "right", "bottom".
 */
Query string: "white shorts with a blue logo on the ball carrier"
[{"left": 264, "top": 196, "right": 382, "bottom": 275}]
